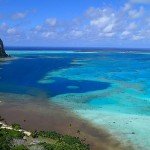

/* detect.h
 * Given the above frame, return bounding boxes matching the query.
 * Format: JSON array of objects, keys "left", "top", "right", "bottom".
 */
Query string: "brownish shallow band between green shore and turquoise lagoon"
[{"left": 0, "top": 93, "right": 133, "bottom": 150}]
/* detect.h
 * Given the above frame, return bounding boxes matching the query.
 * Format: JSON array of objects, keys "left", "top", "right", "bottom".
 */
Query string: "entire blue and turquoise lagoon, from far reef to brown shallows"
[{"left": 0, "top": 51, "right": 150, "bottom": 150}]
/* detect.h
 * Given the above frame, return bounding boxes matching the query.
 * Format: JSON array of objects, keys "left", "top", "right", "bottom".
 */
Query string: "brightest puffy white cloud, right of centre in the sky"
[{"left": 86, "top": 8, "right": 118, "bottom": 39}]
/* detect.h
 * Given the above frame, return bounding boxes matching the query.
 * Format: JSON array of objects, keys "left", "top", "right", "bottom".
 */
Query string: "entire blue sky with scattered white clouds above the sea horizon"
[{"left": 0, "top": 0, "right": 150, "bottom": 48}]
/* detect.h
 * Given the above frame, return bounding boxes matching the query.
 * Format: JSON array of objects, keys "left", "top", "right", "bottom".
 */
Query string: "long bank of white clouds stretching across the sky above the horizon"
[{"left": 0, "top": 2, "right": 150, "bottom": 46}]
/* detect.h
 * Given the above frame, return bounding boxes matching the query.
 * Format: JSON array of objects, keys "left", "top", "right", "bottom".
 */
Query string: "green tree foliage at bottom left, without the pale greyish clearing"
[{"left": 0, "top": 124, "right": 90, "bottom": 150}]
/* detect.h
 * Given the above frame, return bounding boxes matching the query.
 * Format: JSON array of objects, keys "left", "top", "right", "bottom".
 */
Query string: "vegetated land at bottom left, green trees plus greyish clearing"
[{"left": 0, "top": 124, "right": 90, "bottom": 150}]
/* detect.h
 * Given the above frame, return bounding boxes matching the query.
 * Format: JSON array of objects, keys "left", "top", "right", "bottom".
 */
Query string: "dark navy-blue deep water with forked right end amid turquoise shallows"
[{"left": 0, "top": 54, "right": 110, "bottom": 97}]
